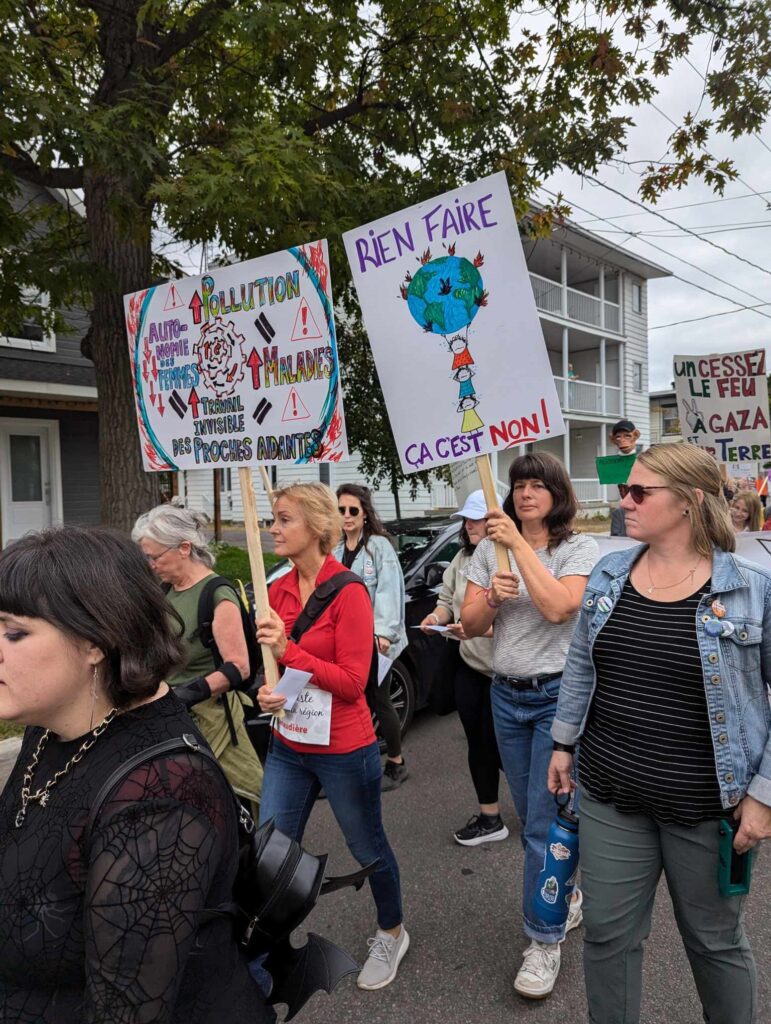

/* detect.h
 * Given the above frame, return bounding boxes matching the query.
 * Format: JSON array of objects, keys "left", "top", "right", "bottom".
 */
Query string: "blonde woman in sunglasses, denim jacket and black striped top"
[{"left": 549, "top": 444, "right": 771, "bottom": 1024}]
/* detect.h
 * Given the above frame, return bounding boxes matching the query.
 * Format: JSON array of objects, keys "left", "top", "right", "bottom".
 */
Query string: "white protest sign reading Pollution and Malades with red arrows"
[{"left": 124, "top": 241, "right": 348, "bottom": 471}]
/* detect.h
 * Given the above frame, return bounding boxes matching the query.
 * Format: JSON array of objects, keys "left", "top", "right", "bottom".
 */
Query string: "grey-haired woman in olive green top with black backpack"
[{"left": 131, "top": 504, "right": 262, "bottom": 812}]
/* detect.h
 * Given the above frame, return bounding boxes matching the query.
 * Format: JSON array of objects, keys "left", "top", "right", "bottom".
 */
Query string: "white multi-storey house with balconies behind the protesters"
[{"left": 179, "top": 212, "right": 670, "bottom": 521}]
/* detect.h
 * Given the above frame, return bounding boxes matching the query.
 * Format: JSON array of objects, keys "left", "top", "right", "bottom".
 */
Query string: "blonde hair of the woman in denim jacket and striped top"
[{"left": 637, "top": 443, "right": 736, "bottom": 558}]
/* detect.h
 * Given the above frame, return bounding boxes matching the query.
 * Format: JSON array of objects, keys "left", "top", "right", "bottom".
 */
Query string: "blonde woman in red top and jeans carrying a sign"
[{"left": 257, "top": 483, "right": 410, "bottom": 989}]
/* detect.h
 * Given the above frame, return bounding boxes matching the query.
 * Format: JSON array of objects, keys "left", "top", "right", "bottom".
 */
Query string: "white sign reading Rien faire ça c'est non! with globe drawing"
[{"left": 344, "top": 173, "right": 565, "bottom": 473}]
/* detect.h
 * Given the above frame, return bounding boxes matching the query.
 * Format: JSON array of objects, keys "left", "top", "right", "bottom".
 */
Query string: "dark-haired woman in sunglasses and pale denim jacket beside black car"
[{"left": 333, "top": 483, "right": 410, "bottom": 792}]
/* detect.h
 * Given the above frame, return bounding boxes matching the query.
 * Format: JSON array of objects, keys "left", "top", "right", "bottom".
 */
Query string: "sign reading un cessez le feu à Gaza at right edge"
[{"left": 674, "top": 348, "right": 771, "bottom": 463}]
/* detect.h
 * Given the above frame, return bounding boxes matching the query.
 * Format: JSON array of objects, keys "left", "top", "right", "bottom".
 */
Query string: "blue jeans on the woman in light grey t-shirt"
[{"left": 493, "top": 676, "right": 565, "bottom": 943}]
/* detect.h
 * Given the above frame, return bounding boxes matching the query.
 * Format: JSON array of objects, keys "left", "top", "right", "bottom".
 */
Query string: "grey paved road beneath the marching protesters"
[{"left": 295, "top": 714, "right": 771, "bottom": 1024}]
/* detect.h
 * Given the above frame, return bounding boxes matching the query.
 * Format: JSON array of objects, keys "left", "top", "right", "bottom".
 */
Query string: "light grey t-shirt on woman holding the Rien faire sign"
[{"left": 465, "top": 534, "right": 600, "bottom": 676}]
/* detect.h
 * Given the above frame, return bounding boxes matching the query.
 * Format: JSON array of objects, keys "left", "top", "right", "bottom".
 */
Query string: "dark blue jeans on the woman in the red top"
[{"left": 260, "top": 736, "right": 402, "bottom": 929}]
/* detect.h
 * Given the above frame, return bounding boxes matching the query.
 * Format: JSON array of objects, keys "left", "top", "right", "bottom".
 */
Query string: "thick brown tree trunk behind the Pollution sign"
[{"left": 84, "top": 171, "right": 161, "bottom": 530}]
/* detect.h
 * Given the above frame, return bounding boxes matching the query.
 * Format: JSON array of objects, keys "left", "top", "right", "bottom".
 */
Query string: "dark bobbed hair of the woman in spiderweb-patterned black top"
[{"left": 0, "top": 526, "right": 184, "bottom": 709}]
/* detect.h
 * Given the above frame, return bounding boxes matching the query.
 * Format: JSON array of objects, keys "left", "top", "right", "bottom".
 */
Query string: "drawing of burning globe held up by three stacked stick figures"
[{"left": 399, "top": 246, "right": 487, "bottom": 433}]
